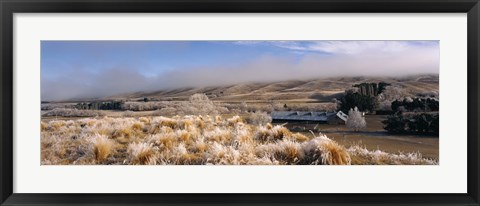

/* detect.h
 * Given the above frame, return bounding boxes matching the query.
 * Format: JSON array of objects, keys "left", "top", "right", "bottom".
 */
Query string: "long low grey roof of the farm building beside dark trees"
[{"left": 271, "top": 111, "right": 337, "bottom": 121}]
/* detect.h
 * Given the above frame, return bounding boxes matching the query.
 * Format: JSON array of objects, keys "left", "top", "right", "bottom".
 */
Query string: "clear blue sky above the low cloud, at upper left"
[{"left": 41, "top": 41, "right": 318, "bottom": 79}]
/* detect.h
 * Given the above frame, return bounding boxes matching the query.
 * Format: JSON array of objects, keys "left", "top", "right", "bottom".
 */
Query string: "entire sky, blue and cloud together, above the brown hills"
[{"left": 41, "top": 41, "right": 440, "bottom": 101}]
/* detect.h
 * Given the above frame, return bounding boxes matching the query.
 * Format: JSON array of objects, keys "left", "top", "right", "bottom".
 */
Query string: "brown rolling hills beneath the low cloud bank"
[{"left": 97, "top": 75, "right": 439, "bottom": 102}]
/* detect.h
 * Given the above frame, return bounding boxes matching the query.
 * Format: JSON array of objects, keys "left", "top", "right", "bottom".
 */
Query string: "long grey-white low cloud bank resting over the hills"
[{"left": 41, "top": 43, "right": 439, "bottom": 101}]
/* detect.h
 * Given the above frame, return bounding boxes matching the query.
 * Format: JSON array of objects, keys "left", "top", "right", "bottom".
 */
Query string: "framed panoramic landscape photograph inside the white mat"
[{"left": 40, "top": 40, "right": 440, "bottom": 165}]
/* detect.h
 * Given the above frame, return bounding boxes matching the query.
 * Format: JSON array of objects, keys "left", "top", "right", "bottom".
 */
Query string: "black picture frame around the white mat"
[{"left": 0, "top": 0, "right": 480, "bottom": 205}]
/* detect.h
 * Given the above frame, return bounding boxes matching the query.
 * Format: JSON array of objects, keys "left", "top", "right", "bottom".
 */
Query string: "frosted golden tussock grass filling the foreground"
[{"left": 41, "top": 113, "right": 438, "bottom": 165}]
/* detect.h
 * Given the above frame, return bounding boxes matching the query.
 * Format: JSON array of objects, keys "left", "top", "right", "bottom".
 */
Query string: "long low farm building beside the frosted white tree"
[{"left": 271, "top": 111, "right": 348, "bottom": 124}]
